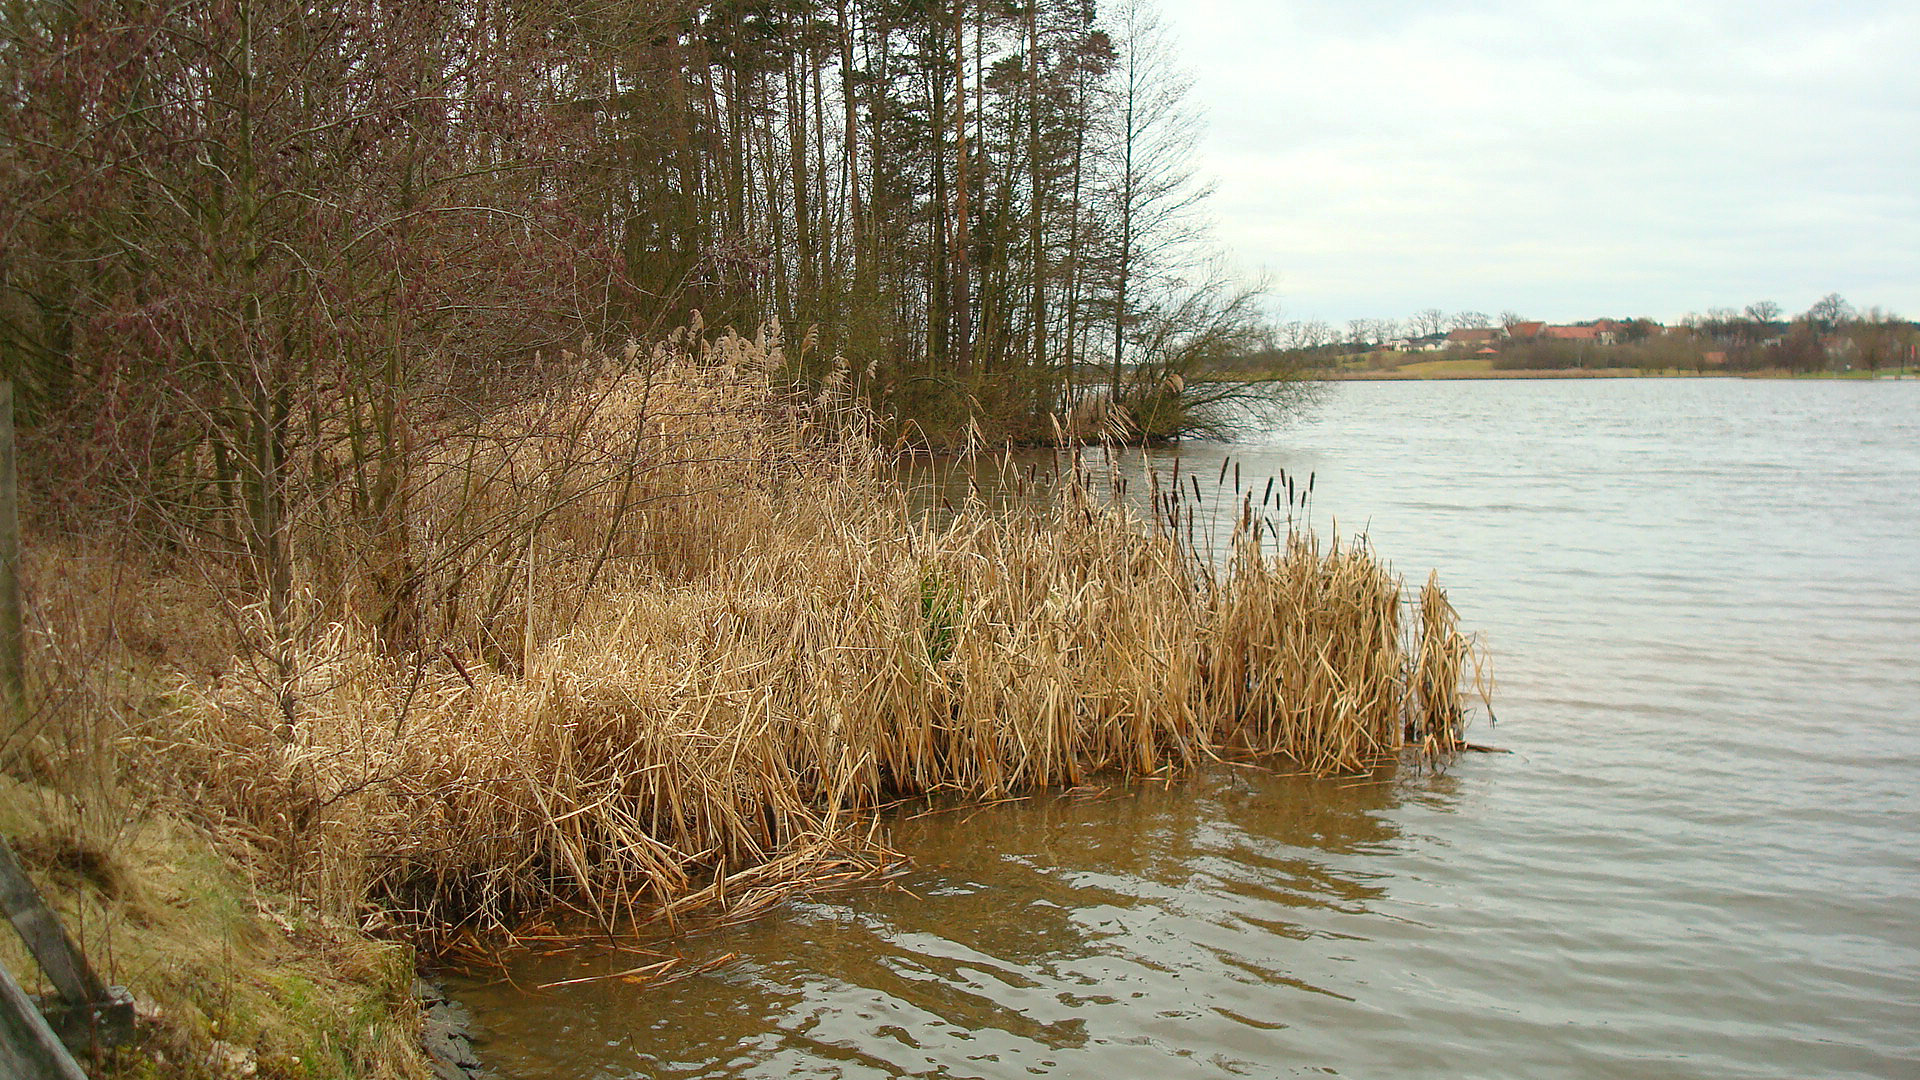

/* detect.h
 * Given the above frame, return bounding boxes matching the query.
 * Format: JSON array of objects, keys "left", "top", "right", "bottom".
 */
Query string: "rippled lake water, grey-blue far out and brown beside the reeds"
[{"left": 441, "top": 379, "right": 1920, "bottom": 1080}]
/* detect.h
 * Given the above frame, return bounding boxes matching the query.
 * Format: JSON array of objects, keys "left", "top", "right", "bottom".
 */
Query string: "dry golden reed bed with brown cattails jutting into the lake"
[{"left": 135, "top": 326, "right": 1471, "bottom": 944}]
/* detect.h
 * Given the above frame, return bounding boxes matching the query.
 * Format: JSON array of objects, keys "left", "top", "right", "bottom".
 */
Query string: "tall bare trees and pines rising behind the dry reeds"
[{"left": 0, "top": 0, "right": 1258, "bottom": 499}]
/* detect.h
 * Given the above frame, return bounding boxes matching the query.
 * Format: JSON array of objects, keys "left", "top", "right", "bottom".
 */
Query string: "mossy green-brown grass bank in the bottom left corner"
[{"left": 0, "top": 778, "right": 426, "bottom": 1080}]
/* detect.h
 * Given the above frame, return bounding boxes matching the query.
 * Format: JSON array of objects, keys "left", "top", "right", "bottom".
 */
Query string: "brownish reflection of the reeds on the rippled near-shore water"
[{"left": 445, "top": 767, "right": 1448, "bottom": 1076}]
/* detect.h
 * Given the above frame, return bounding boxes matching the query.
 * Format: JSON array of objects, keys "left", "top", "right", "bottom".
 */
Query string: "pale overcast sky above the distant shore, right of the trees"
[{"left": 1160, "top": 0, "right": 1920, "bottom": 325}]
